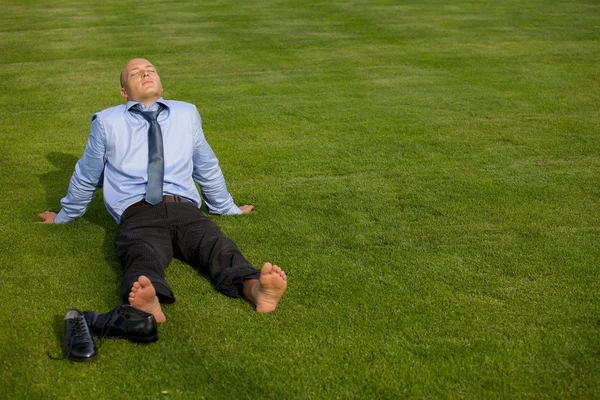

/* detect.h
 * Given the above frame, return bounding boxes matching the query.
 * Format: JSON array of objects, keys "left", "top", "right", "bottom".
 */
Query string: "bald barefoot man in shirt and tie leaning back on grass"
[{"left": 38, "top": 58, "right": 287, "bottom": 323}]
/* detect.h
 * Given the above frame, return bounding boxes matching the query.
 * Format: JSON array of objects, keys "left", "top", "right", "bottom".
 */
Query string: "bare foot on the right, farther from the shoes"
[{"left": 244, "top": 263, "right": 287, "bottom": 313}]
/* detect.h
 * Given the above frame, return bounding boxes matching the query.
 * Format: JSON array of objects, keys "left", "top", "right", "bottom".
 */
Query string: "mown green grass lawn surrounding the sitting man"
[{"left": 0, "top": 0, "right": 600, "bottom": 399}]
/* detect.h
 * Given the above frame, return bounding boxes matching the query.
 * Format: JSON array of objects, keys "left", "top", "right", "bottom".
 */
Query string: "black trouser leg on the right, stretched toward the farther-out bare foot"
[{"left": 169, "top": 203, "right": 260, "bottom": 297}]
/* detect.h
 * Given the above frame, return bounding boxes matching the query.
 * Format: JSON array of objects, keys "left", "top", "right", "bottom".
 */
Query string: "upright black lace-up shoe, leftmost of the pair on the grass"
[{"left": 63, "top": 308, "right": 98, "bottom": 361}]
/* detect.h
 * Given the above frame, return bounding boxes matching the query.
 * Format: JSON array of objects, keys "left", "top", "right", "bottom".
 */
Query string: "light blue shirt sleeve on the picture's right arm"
[{"left": 193, "top": 104, "right": 242, "bottom": 215}]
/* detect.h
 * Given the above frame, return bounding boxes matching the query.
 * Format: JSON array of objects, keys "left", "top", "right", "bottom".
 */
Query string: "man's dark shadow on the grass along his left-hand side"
[{"left": 40, "top": 152, "right": 123, "bottom": 304}]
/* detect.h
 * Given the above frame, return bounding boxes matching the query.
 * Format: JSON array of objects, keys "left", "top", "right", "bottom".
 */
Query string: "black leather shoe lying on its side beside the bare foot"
[{"left": 83, "top": 305, "right": 158, "bottom": 343}]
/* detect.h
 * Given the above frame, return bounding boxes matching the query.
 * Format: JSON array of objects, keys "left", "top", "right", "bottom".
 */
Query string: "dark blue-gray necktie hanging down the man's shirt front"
[{"left": 130, "top": 104, "right": 165, "bottom": 204}]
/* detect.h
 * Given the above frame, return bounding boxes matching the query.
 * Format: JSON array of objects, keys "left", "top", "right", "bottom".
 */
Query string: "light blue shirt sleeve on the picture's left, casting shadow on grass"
[{"left": 54, "top": 115, "right": 106, "bottom": 224}]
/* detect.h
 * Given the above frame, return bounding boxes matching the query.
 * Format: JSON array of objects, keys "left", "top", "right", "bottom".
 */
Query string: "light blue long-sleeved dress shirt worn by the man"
[{"left": 54, "top": 97, "right": 241, "bottom": 224}]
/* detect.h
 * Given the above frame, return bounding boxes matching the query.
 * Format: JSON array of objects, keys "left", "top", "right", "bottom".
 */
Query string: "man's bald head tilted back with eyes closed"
[{"left": 121, "top": 58, "right": 162, "bottom": 106}]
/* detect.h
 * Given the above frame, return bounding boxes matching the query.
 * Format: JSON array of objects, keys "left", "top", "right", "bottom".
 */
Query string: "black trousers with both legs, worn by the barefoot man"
[{"left": 115, "top": 202, "right": 260, "bottom": 304}]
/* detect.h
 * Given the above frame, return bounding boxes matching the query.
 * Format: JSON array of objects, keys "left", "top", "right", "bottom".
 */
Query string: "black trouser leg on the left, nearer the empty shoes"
[{"left": 115, "top": 205, "right": 175, "bottom": 304}]
